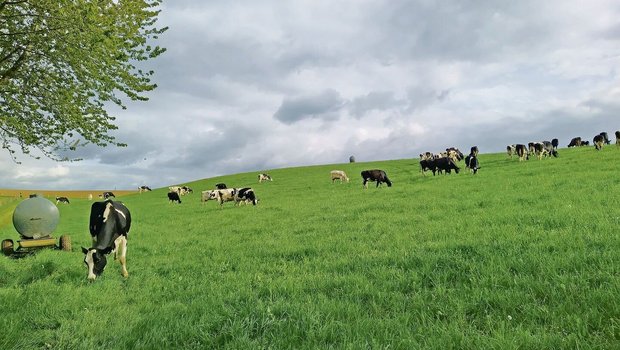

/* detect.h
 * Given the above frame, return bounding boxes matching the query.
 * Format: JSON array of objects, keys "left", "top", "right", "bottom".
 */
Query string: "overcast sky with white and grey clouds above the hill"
[{"left": 0, "top": 0, "right": 620, "bottom": 190}]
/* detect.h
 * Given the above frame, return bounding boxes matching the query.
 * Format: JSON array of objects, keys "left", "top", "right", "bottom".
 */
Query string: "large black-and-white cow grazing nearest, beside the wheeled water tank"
[{"left": 82, "top": 199, "right": 131, "bottom": 281}]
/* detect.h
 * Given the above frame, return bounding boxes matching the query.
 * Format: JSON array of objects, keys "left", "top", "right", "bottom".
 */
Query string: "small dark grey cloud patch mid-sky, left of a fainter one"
[{"left": 273, "top": 89, "right": 344, "bottom": 124}]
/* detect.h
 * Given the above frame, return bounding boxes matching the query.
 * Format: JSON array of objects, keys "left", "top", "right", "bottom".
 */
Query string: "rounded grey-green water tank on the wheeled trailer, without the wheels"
[{"left": 13, "top": 196, "right": 60, "bottom": 239}]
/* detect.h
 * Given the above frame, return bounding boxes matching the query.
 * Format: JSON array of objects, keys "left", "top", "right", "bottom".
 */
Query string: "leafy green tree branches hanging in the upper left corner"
[{"left": 0, "top": 0, "right": 167, "bottom": 162}]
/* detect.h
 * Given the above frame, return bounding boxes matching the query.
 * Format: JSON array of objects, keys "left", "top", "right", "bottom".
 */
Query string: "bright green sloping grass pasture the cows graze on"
[{"left": 0, "top": 145, "right": 620, "bottom": 349}]
